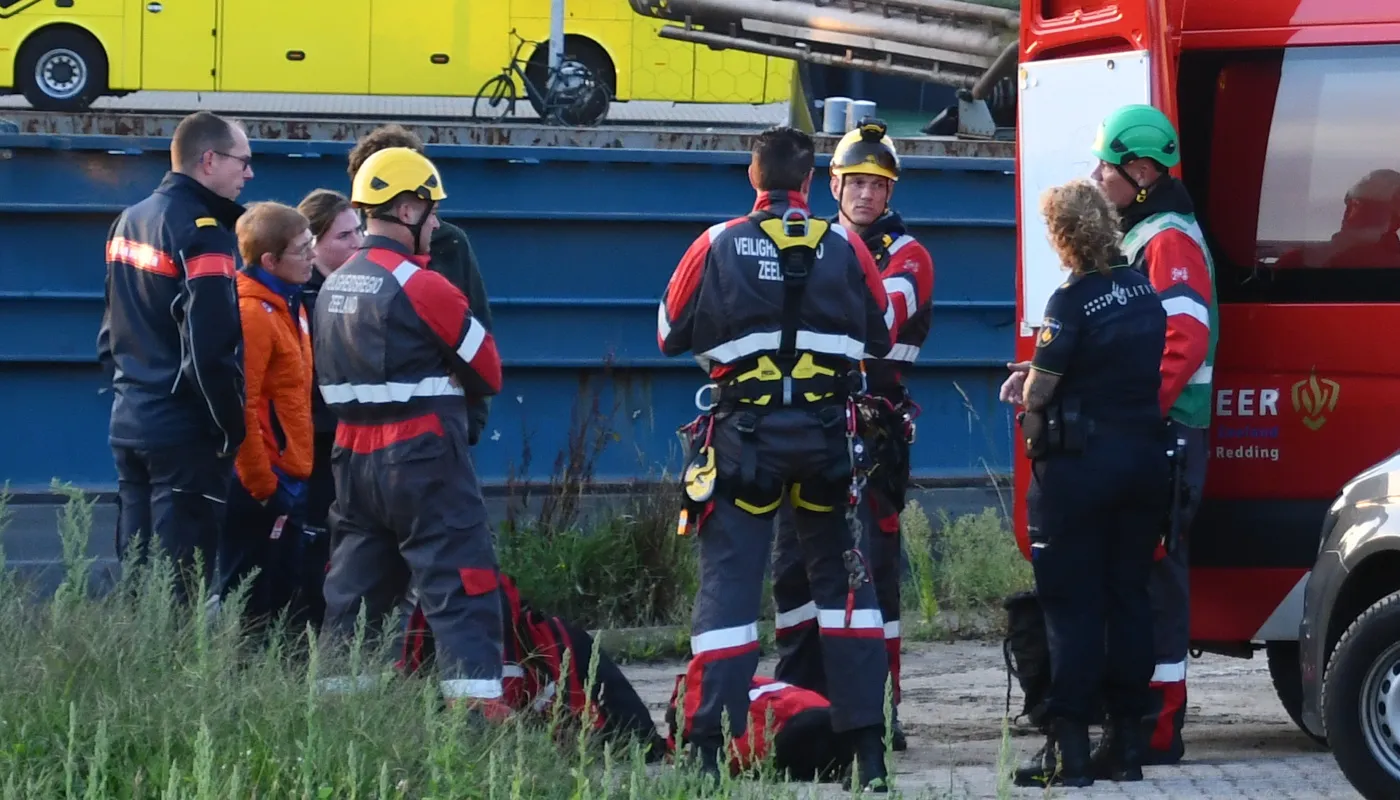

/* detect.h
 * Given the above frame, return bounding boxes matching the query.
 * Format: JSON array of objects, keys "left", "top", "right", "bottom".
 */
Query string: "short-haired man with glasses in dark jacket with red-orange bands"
[{"left": 97, "top": 111, "right": 253, "bottom": 601}]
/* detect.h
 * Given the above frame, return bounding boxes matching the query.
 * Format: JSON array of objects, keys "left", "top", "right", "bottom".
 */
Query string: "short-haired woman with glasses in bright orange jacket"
[{"left": 218, "top": 203, "right": 314, "bottom": 626}]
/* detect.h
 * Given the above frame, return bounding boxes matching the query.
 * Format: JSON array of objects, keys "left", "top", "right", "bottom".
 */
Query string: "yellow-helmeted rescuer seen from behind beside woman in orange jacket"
[{"left": 314, "top": 147, "right": 505, "bottom": 717}]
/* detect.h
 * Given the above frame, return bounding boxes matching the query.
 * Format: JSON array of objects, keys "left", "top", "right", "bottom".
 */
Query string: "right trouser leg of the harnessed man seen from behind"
[{"left": 795, "top": 487, "right": 889, "bottom": 733}]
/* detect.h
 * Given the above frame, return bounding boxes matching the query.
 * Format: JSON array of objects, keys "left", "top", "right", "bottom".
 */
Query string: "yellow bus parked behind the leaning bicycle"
[{"left": 0, "top": 0, "right": 792, "bottom": 111}]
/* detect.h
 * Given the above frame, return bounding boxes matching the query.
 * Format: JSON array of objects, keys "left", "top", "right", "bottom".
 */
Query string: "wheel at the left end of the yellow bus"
[{"left": 14, "top": 28, "right": 106, "bottom": 111}]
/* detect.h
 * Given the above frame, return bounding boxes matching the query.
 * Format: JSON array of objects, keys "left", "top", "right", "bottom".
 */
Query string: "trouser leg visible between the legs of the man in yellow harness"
[{"left": 773, "top": 496, "right": 826, "bottom": 696}]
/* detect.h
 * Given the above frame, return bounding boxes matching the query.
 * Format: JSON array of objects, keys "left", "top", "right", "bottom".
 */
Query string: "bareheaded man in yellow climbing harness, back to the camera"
[{"left": 657, "top": 126, "right": 890, "bottom": 790}]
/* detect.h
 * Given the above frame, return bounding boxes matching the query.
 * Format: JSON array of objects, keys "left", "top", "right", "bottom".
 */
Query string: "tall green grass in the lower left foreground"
[{"left": 0, "top": 486, "right": 1030, "bottom": 800}]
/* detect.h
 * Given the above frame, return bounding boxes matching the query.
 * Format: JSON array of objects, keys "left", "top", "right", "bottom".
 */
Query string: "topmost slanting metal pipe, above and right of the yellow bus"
[{"left": 633, "top": 0, "right": 1011, "bottom": 59}]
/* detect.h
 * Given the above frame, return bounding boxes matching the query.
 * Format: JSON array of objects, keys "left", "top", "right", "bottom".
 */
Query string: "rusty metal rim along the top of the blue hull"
[{"left": 0, "top": 109, "right": 1015, "bottom": 158}]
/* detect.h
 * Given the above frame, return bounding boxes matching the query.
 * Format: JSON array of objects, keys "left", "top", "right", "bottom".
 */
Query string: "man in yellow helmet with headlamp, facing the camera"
[{"left": 773, "top": 119, "right": 934, "bottom": 750}]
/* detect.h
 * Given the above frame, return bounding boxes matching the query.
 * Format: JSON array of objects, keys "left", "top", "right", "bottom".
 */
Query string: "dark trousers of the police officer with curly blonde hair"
[{"left": 1026, "top": 432, "right": 1169, "bottom": 724}]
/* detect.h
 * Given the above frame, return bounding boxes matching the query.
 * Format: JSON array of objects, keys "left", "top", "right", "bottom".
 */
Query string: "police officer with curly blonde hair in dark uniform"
[{"left": 1015, "top": 181, "right": 1170, "bottom": 786}]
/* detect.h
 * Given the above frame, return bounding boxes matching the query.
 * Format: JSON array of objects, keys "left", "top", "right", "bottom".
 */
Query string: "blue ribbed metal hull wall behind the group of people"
[{"left": 0, "top": 135, "right": 1015, "bottom": 492}]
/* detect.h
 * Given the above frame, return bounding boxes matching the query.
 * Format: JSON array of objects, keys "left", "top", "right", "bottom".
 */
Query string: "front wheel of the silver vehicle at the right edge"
[{"left": 1322, "top": 591, "right": 1400, "bottom": 800}]
